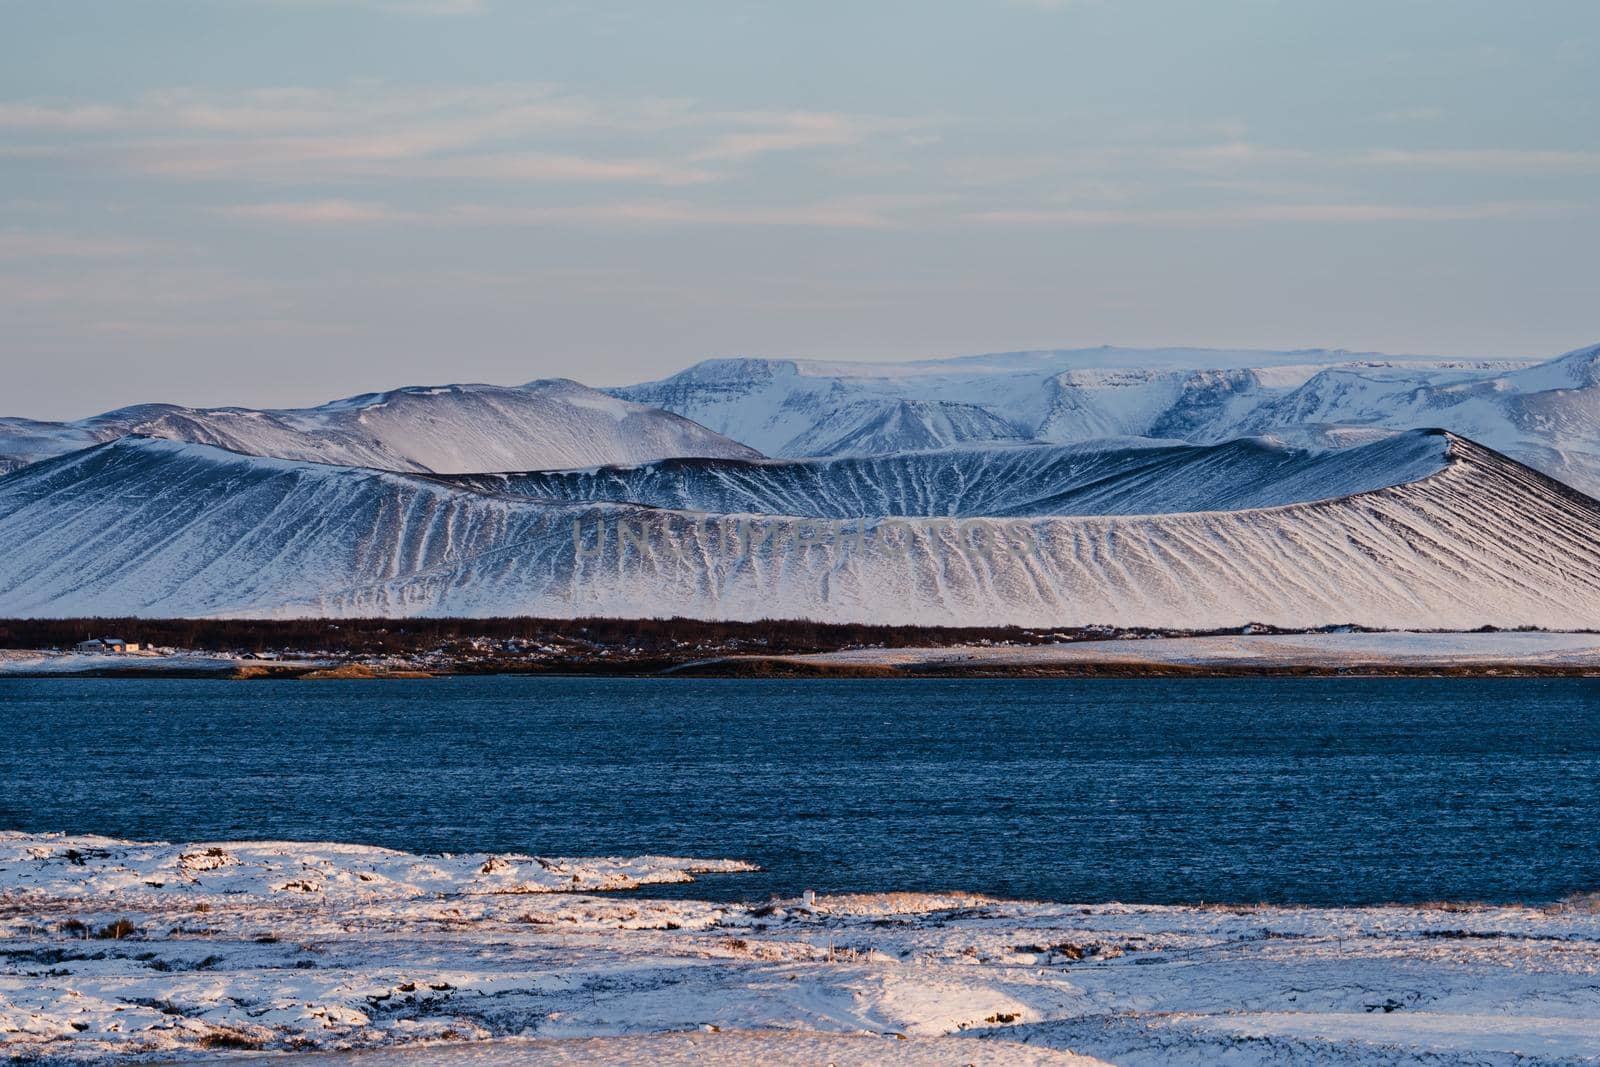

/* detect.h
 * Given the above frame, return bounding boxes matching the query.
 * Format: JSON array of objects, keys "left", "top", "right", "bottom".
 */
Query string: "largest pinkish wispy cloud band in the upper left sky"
[{"left": 0, "top": 85, "right": 926, "bottom": 186}]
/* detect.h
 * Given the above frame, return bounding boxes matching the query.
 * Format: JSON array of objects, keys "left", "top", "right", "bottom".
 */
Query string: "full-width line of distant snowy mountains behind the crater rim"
[{"left": 0, "top": 346, "right": 1600, "bottom": 493}]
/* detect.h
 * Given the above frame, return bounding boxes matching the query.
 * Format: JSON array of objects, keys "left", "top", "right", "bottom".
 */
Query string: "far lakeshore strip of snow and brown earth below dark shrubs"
[{"left": 0, "top": 630, "right": 1600, "bottom": 681}]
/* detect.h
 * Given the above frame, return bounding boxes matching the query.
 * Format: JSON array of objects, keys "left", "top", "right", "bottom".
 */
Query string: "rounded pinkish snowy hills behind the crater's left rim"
[{"left": 0, "top": 379, "right": 757, "bottom": 474}]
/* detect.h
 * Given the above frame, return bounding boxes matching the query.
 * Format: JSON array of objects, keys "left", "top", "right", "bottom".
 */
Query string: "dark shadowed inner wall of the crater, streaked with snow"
[{"left": 453, "top": 432, "right": 1446, "bottom": 518}]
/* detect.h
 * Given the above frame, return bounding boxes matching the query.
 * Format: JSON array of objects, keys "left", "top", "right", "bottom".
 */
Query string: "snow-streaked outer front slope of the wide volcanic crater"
[{"left": 0, "top": 432, "right": 1600, "bottom": 629}]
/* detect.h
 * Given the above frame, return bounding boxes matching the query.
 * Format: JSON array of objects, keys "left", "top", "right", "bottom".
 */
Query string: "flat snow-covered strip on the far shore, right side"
[{"left": 729, "top": 632, "right": 1600, "bottom": 670}]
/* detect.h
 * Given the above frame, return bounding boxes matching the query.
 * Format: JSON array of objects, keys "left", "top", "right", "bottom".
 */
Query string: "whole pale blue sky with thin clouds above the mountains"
[{"left": 0, "top": 0, "right": 1600, "bottom": 418}]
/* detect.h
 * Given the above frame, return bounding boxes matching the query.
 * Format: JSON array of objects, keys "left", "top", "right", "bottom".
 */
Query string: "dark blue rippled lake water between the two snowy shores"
[{"left": 0, "top": 677, "right": 1600, "bottom": 904}]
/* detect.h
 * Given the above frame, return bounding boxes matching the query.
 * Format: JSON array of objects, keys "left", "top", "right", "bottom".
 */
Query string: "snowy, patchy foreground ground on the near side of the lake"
[{"left": 0, "top": 833, "right": 1600, "bottom": 1067}]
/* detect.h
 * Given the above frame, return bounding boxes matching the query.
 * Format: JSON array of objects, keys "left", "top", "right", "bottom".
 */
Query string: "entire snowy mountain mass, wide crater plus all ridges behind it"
[{"left": 0, "top": 340, "right": 1600, "bottom": 629}]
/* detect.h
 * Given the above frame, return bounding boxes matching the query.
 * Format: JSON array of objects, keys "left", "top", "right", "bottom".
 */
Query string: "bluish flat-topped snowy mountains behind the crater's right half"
[{"left": 611, "top": 346, "right": 1600, "bottom": 493}]
